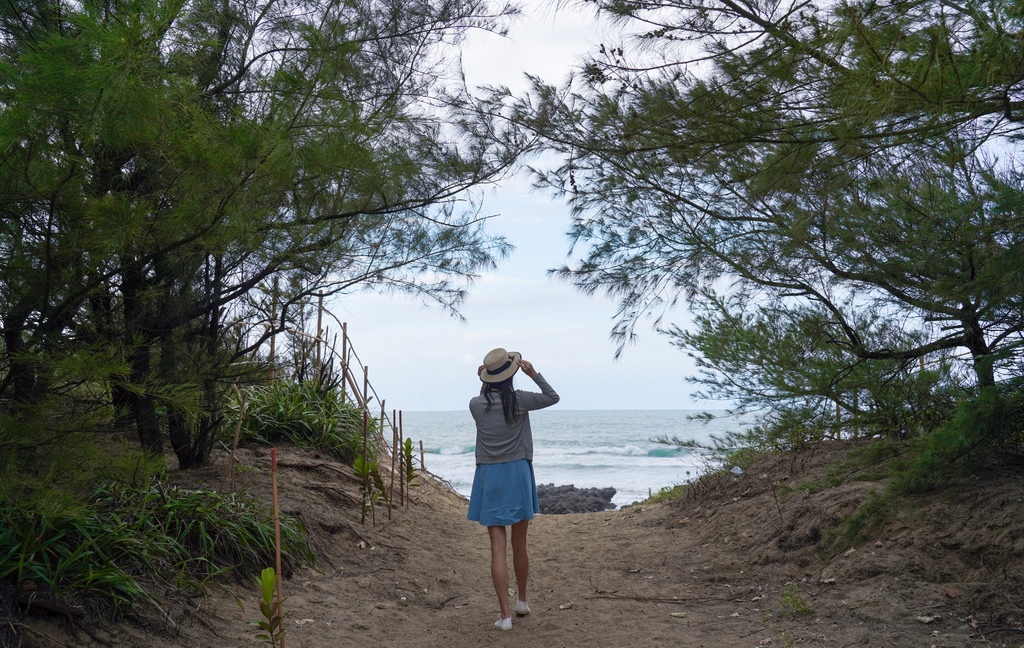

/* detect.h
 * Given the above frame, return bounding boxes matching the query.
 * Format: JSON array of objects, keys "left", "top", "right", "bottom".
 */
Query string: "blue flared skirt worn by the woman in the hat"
[{"left": 466, "top": 459, "right": 541, "bottom": 526}]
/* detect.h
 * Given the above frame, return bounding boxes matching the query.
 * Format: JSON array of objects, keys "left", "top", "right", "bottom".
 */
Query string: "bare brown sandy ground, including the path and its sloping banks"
[{"left": 24, "top": 444, "right": 1003, "bottom": 648}]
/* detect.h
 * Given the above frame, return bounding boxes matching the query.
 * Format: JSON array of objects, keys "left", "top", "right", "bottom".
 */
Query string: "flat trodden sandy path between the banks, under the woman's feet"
[{"left": 258, "top": 481, "right": 737, "bottom": 648}]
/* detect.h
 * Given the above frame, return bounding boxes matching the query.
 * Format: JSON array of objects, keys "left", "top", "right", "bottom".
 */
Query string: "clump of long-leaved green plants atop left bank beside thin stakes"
[{"left": 243, "top": 381, "right": 379, "bottom": 464}]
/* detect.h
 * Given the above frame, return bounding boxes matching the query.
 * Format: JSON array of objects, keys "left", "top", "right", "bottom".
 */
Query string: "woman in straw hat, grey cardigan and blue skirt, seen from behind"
[{"left": 467, "top": 348, "right": 558, "bottom": 630}]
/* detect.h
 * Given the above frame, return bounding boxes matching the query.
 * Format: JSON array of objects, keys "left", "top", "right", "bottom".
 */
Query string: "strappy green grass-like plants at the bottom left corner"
[{"left": 0, "top": 482, "right": 313, "bottom": 612}]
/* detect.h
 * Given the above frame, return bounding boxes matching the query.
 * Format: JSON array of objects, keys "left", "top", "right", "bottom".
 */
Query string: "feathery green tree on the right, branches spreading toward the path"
[{"left": 509, "top": 0, "right": 1024, "bottom": 434}]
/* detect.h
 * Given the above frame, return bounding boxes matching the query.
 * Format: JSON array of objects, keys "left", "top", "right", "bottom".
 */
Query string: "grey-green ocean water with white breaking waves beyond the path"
[{"left": 402, "top": 409, "right": 744, "bottom": 507}]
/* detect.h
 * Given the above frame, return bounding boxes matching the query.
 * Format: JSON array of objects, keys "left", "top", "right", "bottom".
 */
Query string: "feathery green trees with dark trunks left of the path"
[{"left": 0, "top": 0, "right": 524, "bottom": 466}]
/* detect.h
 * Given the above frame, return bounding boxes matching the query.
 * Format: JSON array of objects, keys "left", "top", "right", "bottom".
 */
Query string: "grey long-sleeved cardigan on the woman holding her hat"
[{"left": 469, "top": 374, "right": 558, "bottom": 464}]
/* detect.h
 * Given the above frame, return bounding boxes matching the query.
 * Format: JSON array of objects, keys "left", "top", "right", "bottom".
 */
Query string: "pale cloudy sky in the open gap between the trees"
[{"left": 330, "top": 0, "right": 723, "bottom": 412}]
